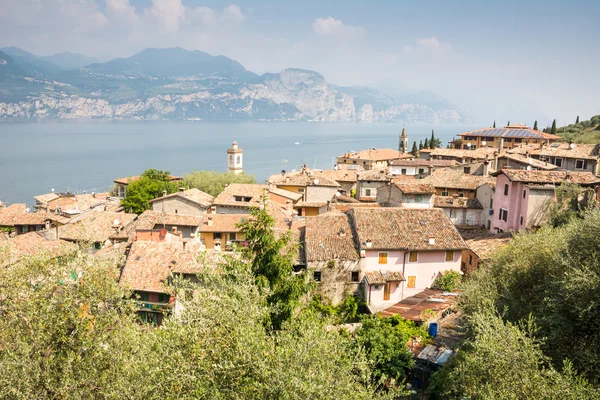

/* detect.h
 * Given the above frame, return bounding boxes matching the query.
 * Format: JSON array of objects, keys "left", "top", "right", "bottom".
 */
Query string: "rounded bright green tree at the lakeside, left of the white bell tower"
[{"left": 121, "top": 169, "right": 177, "bottom": 214}]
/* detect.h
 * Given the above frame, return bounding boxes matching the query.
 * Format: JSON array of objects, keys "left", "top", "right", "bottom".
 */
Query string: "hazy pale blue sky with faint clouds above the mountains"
[{"left": 0, "top": 0, "right": 600, "bottom": 127}]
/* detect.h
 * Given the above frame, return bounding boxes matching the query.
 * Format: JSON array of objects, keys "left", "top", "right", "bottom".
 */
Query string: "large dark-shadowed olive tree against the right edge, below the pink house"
[{"left": 459, "top": 211, "right": 600, "bottom": 384}]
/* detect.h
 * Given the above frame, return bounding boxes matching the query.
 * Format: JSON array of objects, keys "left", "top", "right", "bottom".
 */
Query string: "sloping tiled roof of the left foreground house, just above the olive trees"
[{"left": 119, "top": 241, "right": 183, "bottom": 293}]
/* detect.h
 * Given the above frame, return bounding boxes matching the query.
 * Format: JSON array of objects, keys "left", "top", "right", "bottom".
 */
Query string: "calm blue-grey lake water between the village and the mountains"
[{"left": 0, "top": 120, "right": 476, "bottom": 204}]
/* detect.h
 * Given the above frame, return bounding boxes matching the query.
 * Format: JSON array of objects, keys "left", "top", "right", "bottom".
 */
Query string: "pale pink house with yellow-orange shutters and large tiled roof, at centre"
[{"left": 350, "top": 208, "right": 467, "bottom": 311}]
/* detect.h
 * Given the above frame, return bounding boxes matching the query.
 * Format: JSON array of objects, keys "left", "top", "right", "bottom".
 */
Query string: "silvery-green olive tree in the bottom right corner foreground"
[{"left": 428, "top": 310, "right": 599, "bottom": 400}]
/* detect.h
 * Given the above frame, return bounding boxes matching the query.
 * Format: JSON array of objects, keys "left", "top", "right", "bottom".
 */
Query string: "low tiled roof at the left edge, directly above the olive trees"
[{"left": 0, "top": 232, "right": 77, "bottom": 266}]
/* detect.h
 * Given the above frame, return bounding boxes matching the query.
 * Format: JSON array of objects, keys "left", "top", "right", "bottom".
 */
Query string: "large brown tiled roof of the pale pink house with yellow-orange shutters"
[{"left": 349, "top": 207, "right": 466, "bottom": 251}]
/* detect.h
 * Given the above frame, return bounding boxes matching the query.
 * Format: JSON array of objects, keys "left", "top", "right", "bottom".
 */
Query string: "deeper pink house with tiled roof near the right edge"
[{"left": 490, "top": 168, "right": 600, "bottom": 233}]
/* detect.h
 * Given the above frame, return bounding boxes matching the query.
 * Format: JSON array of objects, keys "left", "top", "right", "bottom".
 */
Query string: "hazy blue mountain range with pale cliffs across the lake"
[{"left": 0, "top": 47, "right": 470, "bottom": 123}]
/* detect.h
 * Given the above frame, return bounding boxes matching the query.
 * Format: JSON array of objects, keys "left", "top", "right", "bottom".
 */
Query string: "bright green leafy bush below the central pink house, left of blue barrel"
[{"left": 355, "top": 315, "right": 428, "bottom": 382}]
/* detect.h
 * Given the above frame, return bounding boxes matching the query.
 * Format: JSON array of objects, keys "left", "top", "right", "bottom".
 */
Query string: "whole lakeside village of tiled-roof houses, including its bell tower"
[{"left": 0, "top": 124, "right": 600, "bottom": 376}]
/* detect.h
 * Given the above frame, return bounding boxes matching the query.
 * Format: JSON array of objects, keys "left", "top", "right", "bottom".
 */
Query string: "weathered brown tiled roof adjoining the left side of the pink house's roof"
[{"left": 304, "top": 212, "right": 360, "bottom": 262}]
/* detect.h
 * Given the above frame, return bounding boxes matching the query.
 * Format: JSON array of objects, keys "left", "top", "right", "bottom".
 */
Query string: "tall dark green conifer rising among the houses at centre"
[{"left": 240, "top": 200, "right": 310, "bottom": 329}]
